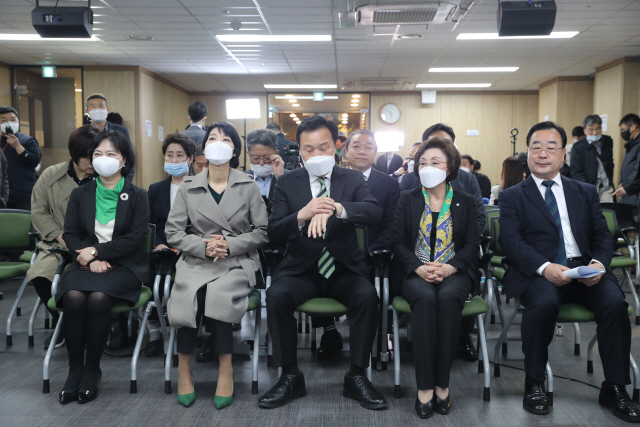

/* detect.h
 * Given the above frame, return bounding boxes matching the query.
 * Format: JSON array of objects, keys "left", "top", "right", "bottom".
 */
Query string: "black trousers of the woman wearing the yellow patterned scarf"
[{"left": 401, "top": 273, "right": 472, "bottom": 390}]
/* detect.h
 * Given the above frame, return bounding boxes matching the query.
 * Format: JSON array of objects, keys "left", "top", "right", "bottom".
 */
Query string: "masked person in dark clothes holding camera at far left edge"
[{"left": 0, "top": 107, "right": 41, "bottom": 211}]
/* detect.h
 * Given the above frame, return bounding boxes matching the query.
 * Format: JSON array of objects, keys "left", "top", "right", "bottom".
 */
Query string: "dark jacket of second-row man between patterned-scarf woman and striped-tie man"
[{"left": 364, "top": 169, "right": 400, "bottom": 252}]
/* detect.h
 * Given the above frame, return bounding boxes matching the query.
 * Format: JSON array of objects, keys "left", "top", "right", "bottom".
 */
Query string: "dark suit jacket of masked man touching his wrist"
[{"left": 267, "top": 166, "right": 382, "bottom": 280}]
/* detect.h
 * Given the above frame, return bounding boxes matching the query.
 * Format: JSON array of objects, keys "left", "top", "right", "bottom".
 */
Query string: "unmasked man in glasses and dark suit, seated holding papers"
[{"left": 499, "top": 122, "right": 640, "bottom": 422}]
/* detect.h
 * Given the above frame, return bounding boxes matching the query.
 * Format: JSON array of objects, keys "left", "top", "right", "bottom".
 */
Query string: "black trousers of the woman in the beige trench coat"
[{"left": 177, "top": 286, "right": 233, "bottom": 355}]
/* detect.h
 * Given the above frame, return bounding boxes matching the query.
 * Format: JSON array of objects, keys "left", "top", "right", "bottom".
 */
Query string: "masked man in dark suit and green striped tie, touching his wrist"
[{"left": 258, "top": 116, "right": 387, "bottom": 409}]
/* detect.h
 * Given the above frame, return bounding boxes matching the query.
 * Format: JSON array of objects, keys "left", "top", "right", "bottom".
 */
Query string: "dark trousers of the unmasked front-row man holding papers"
[{"left": 520, "top": 262, "right": 631, "bottom": 385}]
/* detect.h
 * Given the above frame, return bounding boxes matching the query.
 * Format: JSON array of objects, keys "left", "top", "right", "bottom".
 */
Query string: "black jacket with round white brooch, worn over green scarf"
[{"left": 62, "top": 181, "right": 151, "bottom": 283}]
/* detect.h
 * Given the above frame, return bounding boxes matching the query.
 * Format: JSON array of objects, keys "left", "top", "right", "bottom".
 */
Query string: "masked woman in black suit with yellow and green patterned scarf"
[{"left": 392, "top": 138, "right": 480, "bottom": 418}]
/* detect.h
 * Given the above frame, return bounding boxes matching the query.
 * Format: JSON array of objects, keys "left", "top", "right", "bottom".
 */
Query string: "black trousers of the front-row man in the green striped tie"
[{"left": 267, "top": 262, "right": 379, "bottom": 368}]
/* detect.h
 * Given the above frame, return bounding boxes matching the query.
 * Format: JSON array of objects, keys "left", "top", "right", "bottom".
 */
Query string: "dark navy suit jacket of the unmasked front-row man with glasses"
[{"left": 498, "top": 176, "right": 615, "bottom": 298}]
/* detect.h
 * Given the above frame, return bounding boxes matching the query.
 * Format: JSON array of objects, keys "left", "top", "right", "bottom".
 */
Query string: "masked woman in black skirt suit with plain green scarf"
[{"left": 55, "top": 131, "right": 150, "bottom": 404}]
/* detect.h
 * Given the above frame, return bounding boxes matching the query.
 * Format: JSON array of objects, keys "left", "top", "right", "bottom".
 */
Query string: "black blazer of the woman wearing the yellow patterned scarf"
[{"left": 391, "top": 188, "right": 480, "bottom": 288}]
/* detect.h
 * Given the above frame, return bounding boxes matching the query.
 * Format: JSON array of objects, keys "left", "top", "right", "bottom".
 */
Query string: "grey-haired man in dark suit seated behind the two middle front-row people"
[{"left": 314, "top": 129, "right": 400, "bottom": 359}]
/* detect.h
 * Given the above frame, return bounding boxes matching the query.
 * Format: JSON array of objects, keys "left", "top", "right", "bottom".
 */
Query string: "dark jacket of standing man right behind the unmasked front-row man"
[{"left": 571, "top": 135, "right": 615, "bottom": 188}]
